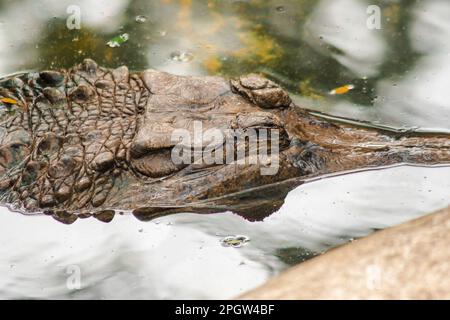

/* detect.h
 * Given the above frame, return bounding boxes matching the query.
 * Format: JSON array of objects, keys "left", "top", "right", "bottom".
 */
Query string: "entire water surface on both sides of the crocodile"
[{"left": 0, "top": 0, "right": 450, "bottom": 298}]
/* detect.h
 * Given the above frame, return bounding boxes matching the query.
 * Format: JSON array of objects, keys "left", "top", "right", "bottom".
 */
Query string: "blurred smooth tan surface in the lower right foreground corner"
[{"left": 239, "top": 207, "right": 450, "bottom": 299}]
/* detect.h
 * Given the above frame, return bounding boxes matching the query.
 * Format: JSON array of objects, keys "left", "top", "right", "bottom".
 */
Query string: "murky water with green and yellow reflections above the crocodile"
[{"left": 0, "top": 0, "right": 450, "bottom": 129}]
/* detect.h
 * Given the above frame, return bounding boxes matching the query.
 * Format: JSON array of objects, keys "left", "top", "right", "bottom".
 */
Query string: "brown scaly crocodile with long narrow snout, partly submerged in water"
[{"left": 0, "top": 59, "right": 450, "bottom": 223}]
